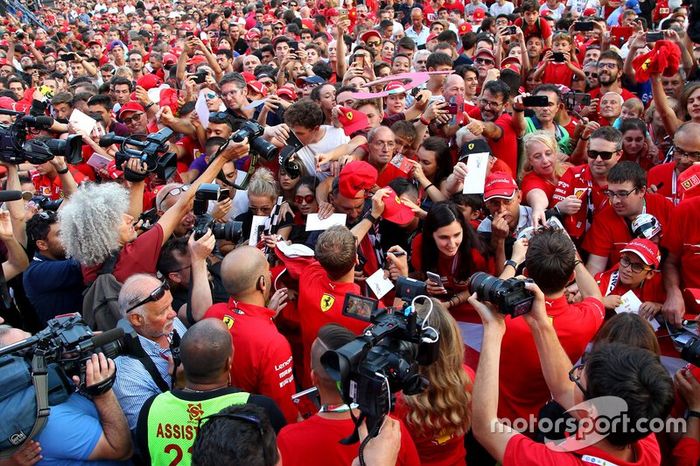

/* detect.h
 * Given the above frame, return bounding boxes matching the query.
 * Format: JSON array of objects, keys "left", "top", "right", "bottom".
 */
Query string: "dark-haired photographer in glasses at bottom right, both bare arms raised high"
[{"left": 469, "top": 276, "right": 673, "bottom": 466}]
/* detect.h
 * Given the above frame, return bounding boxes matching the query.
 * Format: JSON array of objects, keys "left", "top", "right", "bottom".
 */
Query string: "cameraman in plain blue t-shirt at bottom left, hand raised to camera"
[{"left": 0, "top": 326, "right": 132, "bottom": 465}]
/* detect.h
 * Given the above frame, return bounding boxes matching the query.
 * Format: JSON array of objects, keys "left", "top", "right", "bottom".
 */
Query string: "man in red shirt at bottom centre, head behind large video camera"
[{"left": 277, "top": 324, "right": 420, "bottom": 466}]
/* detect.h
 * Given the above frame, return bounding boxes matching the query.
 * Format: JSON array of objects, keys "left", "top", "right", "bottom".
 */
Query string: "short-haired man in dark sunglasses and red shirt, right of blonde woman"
[{"left": 554, "top": 126, "right": 622, "bottom": 244}]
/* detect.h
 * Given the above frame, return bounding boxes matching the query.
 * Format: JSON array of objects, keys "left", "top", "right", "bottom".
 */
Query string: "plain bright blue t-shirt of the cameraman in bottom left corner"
[{"left": 36, "top": 393, "right": 128, "bottom": 466}]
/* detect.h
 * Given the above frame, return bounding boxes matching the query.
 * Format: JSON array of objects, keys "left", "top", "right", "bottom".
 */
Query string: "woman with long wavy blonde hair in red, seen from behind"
[{"left": 396, "top": 299, "right": 474, "bottom": 466}]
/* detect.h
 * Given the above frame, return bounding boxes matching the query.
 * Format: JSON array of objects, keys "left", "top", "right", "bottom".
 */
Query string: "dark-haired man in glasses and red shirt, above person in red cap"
[{"left": 583, "top": 161, "right": 673, "bottom": 274}]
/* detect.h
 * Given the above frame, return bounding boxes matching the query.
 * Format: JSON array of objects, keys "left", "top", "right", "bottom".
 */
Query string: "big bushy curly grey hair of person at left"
[{"left": 58, "top": 183, "right": 129, "bottom": 266}]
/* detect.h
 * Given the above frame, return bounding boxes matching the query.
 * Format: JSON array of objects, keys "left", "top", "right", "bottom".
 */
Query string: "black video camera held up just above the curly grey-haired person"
[{"left": 100, "top": 128, "right": 177, "bottom": 180}]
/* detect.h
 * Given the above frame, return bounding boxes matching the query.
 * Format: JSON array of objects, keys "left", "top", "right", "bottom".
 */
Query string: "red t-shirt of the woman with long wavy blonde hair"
[{"left": 394, "top": 365, "right": 474, "bottom": 466}]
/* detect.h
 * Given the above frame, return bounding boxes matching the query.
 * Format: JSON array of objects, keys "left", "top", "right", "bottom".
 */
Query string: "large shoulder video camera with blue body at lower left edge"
[{"left": 0, "top": 313, "right": 124, "bottom": 457}]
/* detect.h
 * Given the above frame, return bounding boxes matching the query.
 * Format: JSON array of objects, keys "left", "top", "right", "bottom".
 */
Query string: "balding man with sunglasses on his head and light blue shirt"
[{"left": 114, "top": 273, "right": 187, "bottom": 431}]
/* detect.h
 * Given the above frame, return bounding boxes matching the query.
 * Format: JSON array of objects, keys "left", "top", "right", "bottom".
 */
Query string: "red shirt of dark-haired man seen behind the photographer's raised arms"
[{"left": 498, "top": 296, "right": 605, "bottom": 420}]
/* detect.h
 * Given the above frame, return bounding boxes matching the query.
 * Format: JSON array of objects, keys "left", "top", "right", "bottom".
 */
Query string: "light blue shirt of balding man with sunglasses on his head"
[{"left": 112, "top": 317, "right": 187, "bottom": 431}]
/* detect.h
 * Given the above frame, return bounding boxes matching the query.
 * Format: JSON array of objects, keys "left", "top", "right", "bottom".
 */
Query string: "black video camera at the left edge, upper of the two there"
[{"left": 0, "top": 109, "right": 83, "bottom": 165}]
